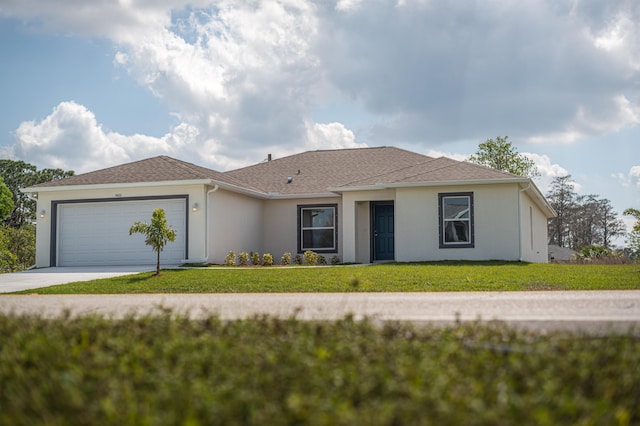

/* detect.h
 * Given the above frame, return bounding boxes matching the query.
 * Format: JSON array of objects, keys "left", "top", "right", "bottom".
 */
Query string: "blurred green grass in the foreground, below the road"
[{"left": 0, "top": 314, "right": 640, "bottom": 425}]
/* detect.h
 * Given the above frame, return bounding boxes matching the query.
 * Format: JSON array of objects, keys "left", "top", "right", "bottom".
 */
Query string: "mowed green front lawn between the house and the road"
[{"left": 22, "top": 262, "right": 640, "bottom": 294}]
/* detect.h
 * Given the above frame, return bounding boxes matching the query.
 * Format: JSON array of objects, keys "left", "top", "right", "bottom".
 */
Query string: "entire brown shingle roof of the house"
[{"left": 31, "top": 147, "right": 523, "bottom": 195}]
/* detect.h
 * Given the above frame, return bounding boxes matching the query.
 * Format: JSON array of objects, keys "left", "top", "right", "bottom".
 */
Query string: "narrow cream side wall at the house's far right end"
[{"left": 520, "top": 192, "right": 549, "bottom": 263}]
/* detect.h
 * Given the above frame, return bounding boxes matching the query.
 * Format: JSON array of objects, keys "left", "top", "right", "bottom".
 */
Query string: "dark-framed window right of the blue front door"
[{"left": 438, "top": 192, "right": 474, "bottom": 248}]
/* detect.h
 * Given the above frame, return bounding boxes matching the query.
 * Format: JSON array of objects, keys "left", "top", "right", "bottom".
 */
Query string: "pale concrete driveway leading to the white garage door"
[{"left": 0, "top": 265, "right": 154, "bottom": 293}]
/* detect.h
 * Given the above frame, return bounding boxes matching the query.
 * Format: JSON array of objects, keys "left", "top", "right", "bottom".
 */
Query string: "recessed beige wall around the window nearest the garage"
[{"left": 263, "top": 197, "right": 345, "bottom": 263}]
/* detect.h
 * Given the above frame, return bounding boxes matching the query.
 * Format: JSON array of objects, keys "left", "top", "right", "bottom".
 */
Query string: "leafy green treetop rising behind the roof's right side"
[{"left": 469, "top": 136, "right": 540, "bottom": 178}]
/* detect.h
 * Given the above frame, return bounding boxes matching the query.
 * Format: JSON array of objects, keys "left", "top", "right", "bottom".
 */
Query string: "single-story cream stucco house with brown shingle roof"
[{"left": 24, "top": 147, "right": 555, "bottom": 267}]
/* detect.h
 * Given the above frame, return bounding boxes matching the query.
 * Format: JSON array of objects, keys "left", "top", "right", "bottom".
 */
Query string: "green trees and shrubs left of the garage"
[{"left": 0, "top": 159, "right": 74, "bottom": 272}]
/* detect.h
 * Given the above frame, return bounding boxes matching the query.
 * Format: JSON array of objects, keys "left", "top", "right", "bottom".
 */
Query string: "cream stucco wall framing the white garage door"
[{"left": 36, "top": 185, "right": 206, "bottom": 268}]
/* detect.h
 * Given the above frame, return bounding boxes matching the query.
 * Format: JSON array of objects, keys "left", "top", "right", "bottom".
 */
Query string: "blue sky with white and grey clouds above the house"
[{"left": 0, "top": 0, "right": 640, "bottom": 245}]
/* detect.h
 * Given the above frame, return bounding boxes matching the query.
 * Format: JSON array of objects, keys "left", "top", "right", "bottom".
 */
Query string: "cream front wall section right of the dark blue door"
[{"left": 395, "top": 184, "right": 520, "bottom": 262}]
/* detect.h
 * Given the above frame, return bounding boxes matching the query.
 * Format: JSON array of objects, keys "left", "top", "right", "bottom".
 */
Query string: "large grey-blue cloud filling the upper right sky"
[{"left": 319, "top": 0, "right": 640, "bottom": 144}]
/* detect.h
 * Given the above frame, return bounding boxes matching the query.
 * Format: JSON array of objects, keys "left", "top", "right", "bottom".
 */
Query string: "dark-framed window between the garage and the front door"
[{"left": 298, "top": 204, "right": 338, "bottom": 253}]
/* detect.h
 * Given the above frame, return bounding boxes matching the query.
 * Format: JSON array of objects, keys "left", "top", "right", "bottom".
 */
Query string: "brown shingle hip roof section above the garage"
[{"left": 27, "top": 156, "right": 252, "bottom": 188}]
